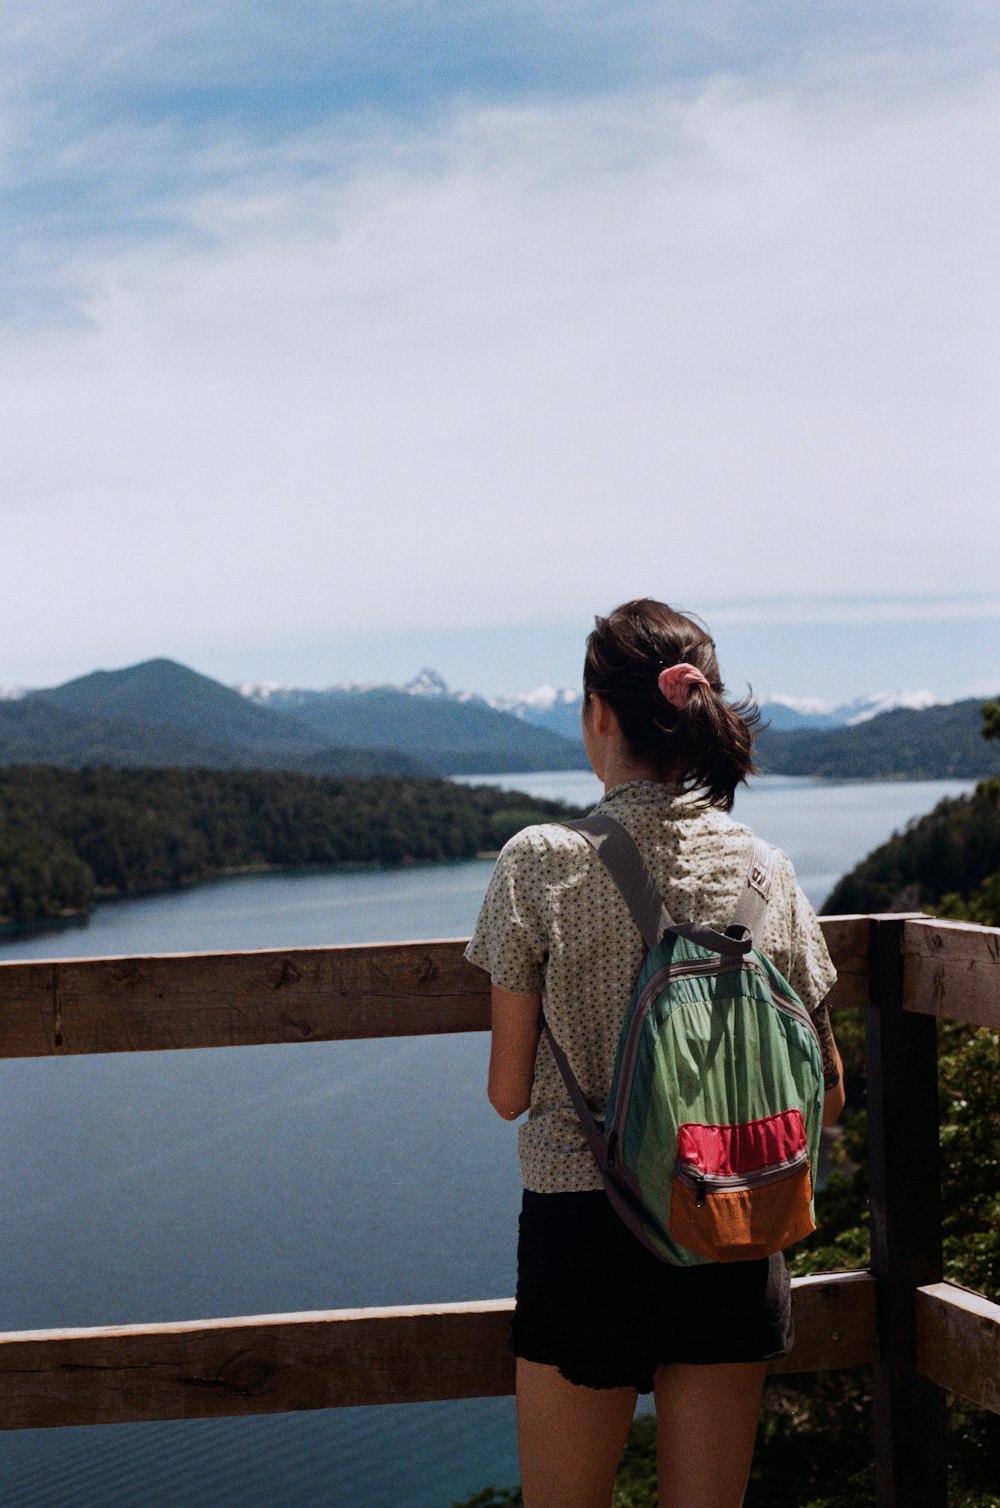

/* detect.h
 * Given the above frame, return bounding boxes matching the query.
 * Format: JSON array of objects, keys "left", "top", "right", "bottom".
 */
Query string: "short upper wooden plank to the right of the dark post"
[{"left": 903, "top": 918, "right": 1000, "bottom": 1028}]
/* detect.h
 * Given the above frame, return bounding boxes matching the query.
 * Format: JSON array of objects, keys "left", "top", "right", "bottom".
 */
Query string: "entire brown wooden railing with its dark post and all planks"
[{"left": 0, "top": 915, "right": 1000, "bottom": 1508}]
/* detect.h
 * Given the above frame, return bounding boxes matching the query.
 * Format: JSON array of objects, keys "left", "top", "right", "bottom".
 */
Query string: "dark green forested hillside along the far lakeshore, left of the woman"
[{"left": 0, "top": 766, "right": 572, "bottom": 923}]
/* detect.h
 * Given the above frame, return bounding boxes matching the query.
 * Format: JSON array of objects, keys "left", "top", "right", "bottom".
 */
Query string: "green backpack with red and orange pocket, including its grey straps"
[{"left": 543, "top": 813, "right": 824, "bottom": 1267}]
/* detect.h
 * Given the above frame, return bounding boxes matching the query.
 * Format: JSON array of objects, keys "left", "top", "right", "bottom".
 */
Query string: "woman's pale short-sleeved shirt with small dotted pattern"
[{"left": 466, "top": 780, "right": 837, "bottom": 1194}]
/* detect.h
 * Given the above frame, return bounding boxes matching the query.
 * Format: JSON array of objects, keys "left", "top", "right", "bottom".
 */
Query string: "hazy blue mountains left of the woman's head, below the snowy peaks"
[{"left": 0, "top": 659, "right": 585, "bottom": 777}]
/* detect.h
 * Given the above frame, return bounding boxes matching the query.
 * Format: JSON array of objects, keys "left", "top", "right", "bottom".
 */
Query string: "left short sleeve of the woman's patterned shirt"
[{"left": 465, "top": 828, "right": 549, "bottom": 995}]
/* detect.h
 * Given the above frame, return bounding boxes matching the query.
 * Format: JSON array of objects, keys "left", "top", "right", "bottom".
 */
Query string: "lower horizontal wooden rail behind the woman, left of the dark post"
[{"left": 0, "top": 1273, "right": 876, "bottom": 1430}]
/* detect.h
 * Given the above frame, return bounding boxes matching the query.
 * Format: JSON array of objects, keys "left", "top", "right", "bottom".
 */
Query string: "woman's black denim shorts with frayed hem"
[{"left": 511, "top": 1190, "right": 793, "bottom": 1393}]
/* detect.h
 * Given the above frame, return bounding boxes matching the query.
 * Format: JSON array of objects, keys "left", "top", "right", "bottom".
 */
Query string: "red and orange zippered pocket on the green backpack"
[{"left": 670, "top": 1110, "right": 816, "bottom": 1262}]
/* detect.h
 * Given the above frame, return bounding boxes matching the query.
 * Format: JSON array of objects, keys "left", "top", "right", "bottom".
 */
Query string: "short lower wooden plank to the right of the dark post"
[{"left": 917, "top": 1283, "right": 1000, "bottom": 1413}]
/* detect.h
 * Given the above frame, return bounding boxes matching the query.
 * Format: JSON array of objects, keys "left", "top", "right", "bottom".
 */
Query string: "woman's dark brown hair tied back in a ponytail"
[{"left": 584, "top": 597, "right": 760, "bottom": 811}]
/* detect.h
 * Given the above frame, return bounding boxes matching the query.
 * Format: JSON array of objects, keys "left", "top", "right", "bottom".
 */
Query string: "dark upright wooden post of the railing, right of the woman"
[{"left": 866, "top": 915, "right": 947, "bottom": 1508}]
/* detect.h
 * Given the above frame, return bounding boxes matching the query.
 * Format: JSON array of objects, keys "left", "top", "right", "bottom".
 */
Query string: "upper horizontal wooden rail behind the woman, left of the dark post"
[{"left": 0, "top": 917, "right": 869, "bottom": 1059}]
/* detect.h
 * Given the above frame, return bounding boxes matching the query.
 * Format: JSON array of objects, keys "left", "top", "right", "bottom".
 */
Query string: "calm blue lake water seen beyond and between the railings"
[{"left": 0, "top": 772, "right": 970, "bottom": 1508}]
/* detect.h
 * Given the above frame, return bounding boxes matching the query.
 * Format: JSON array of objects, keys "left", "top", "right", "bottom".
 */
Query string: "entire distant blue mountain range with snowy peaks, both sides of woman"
[{"left": 0, "top": 659, "right": 1000, "bottom": 780}]
